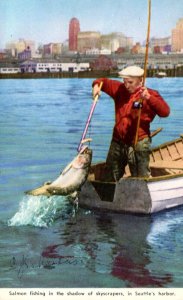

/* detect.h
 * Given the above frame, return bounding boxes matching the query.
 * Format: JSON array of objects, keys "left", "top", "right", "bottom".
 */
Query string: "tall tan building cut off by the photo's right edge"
[{"left": 172, "top": 18, "right": 183, "bottom": 52}]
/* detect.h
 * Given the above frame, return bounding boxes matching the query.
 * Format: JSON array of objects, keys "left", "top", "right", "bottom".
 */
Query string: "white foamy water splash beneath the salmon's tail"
[{"left": 8, "top": 195, "right": 68, "bottom": 227}]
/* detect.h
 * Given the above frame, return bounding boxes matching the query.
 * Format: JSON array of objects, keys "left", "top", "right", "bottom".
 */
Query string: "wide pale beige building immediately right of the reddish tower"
[{"left": 78, "top": 31, "right": 101, "bottom": 53}]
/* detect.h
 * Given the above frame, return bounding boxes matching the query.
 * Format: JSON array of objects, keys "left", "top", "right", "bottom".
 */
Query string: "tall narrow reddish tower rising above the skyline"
[{"left": 69, "top": 18, "right": 80, "bottom": 51}]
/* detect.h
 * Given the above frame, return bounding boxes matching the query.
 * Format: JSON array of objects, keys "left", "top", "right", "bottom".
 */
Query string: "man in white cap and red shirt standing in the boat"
[{"left": 92, "top": 66, "right": 170, "bottom": 181}]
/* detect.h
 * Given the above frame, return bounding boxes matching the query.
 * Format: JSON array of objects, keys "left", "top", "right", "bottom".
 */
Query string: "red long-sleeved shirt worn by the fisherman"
[{"left": 93, "top": 78, "right": 170, "bottom": 145}]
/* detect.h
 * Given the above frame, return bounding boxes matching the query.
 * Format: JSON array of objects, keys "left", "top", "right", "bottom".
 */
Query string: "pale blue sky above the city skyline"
[{"left": 0, "top": 0, "right": 183, "bottom": 49}]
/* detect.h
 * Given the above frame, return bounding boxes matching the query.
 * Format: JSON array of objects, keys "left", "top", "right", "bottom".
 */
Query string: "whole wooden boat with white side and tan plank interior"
[{"left": 78, "top": 135, "right": 183, "bottom": 214}]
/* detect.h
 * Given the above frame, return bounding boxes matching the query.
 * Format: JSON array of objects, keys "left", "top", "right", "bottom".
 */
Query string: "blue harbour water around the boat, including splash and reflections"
[{"left": 0, "top": 78, "right": 183, "bottom": 288}]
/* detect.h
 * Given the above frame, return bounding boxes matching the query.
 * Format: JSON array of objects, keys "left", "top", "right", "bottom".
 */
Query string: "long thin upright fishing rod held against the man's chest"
[{"left": 134, "top": 0, "right": 151, "bottom": 146}]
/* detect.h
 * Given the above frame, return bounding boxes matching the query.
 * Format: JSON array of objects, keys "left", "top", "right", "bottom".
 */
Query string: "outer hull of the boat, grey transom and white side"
[{"left": 78, "top": 175, "right": 183, "bottom": 214}]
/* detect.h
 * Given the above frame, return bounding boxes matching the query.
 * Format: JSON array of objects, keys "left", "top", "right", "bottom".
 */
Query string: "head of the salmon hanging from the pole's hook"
[{"left": 72, "top": 146, "right": 92, "bottom": 169}]
